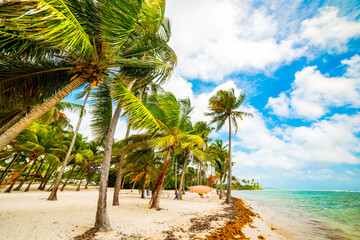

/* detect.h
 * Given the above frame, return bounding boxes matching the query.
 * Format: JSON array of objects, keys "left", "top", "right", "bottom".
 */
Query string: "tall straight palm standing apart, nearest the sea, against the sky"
[{"left": 205, "top": 88, "right": 252, "bottom": 203}]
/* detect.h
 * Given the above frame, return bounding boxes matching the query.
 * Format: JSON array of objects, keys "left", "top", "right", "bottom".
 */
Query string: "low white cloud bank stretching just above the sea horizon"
[{"left": 234, "top": 113, "right": 360, "bottom": 169}]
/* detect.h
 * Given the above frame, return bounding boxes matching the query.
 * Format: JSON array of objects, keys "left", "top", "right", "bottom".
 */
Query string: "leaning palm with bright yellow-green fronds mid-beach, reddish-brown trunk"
[{"left": 118, "top": 92, "right": 204, "bottom": 208}]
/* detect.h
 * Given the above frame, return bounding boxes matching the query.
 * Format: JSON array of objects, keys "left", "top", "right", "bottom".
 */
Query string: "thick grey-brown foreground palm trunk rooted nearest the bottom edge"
[{"left": 95, "top": 80, "right": 136, "bottom": 231}]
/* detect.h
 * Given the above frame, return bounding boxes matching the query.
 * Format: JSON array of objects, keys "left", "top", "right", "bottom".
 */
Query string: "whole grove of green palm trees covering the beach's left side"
[{"left": 0, "top": 0, "right": 260, "bottom": 231}]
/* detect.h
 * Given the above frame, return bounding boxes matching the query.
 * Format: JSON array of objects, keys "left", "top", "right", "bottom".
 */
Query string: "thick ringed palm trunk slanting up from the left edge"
[{"left": 0, "top": 78, "right": 85, "bottom": 151}]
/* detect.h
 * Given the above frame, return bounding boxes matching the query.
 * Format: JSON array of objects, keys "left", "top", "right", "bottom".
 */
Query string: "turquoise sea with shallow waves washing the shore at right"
[{"left": 233, "top": 189, "right": 360, "bottom": 240}]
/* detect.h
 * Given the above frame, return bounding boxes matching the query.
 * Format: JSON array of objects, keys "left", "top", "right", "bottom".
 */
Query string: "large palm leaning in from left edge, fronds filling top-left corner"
[{"left": 0, "top": 0, "right": 172, "bottom": 150}]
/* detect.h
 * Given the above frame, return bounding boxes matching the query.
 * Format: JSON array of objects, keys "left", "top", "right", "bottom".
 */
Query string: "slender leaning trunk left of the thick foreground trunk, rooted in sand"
[{"left": 47, "top": 88, "right": 91, "bottom": 201}]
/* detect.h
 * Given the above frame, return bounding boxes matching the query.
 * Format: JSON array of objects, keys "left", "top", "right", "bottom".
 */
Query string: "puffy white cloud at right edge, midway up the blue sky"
[{"left": 266, "top": 55, "right": 360, "bottom": 120}]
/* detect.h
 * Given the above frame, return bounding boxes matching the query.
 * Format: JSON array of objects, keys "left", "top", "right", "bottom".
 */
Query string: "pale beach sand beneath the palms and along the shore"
[{"left": 0, "top": 185, "right": 284, "bottom": 240}]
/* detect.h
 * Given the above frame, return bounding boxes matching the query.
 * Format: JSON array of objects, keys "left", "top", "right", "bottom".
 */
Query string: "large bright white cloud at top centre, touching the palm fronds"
[{"left": 167, "top": 0, "right": 304, "bottom": 81}]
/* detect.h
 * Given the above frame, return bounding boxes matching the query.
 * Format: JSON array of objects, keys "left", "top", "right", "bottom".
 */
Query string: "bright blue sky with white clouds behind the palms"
[{"left": 65, "top": 0, "right": 360, "bottom": 190}]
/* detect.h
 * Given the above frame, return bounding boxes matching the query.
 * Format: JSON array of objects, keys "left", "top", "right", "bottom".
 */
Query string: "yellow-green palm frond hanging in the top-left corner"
[{"left": 0, "top": 0, "right": 96, "bottom": 58}]
